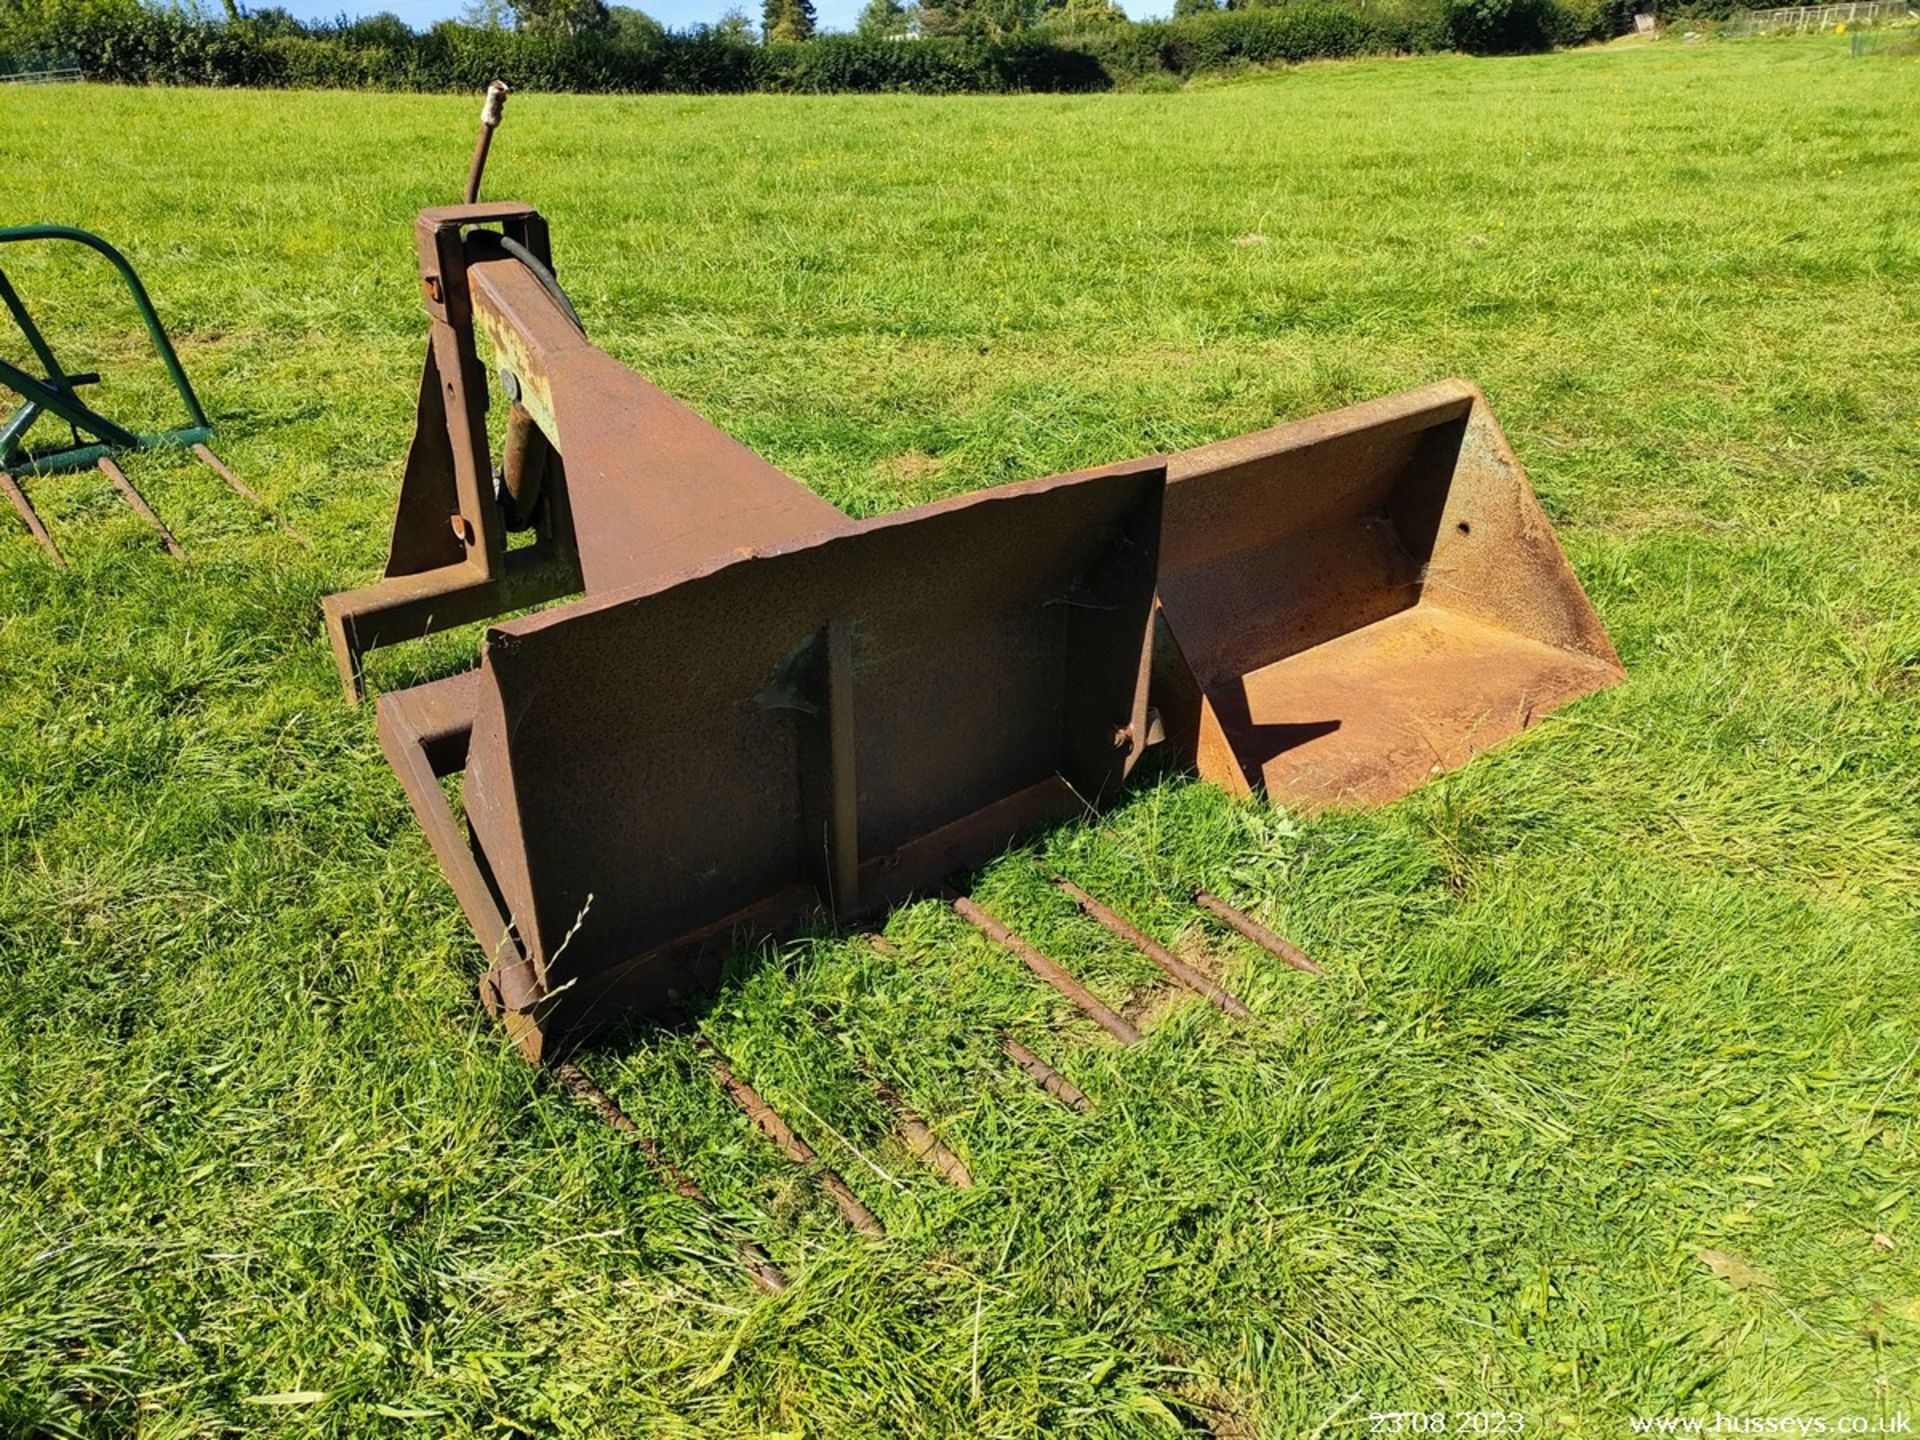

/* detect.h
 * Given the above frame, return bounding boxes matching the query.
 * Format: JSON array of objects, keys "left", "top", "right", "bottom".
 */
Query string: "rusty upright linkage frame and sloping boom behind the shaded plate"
[{"left": 324, "top": 202, "right": 852, "bottom": 701}]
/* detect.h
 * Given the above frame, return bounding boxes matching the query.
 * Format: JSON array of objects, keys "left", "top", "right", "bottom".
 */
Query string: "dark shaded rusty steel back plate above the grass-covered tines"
[{"left": 463, "top": 463, "right": 1162, "bottom": 1044}]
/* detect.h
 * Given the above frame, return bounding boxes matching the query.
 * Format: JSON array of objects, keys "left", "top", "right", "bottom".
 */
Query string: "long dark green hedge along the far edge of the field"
[{"left": 0, "top": 0, "right": 1624, "bottom": 94}]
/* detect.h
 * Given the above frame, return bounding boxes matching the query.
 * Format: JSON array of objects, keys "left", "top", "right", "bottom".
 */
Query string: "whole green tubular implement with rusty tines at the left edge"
[{"left": 0, "top": 225, "right": 291, "bottom": 564}]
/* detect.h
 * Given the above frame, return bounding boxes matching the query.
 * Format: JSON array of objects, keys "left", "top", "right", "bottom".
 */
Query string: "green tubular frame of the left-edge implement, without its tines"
[{"left": 0, "top": 225, "right": 213, "bottom": 474}]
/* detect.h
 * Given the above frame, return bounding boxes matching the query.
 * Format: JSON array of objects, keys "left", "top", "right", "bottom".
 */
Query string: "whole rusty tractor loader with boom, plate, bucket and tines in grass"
[{"left": 324, "top": 90, "right": 1620, "bottom": 1290}]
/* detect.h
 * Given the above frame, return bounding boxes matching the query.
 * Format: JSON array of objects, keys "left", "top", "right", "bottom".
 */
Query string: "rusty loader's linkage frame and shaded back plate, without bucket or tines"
[{"left": 324, "top": 204, "right": 1165, "bottom": 1054}]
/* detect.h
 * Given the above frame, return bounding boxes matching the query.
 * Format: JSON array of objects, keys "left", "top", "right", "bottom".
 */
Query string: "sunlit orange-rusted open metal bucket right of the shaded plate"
[{"left": 1154, "top": 380, "right": 1624, "bottom": 810}]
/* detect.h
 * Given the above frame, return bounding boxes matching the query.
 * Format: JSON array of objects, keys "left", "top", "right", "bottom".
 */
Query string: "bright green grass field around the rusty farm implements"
[{"left": 0, "top": 36, "right": 1920, "bottom": 1440}]
